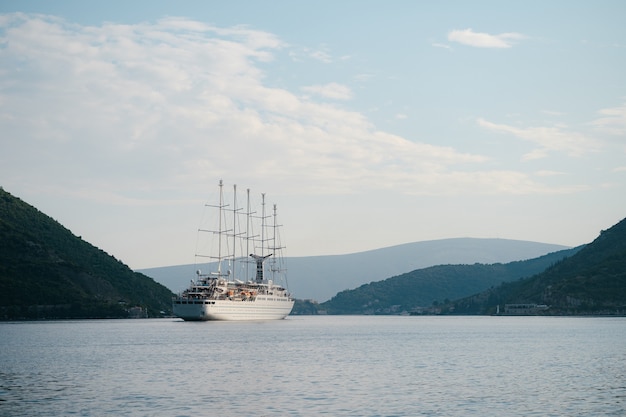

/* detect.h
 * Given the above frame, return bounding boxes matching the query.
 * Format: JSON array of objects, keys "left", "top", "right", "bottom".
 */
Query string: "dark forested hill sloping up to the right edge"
[{"left": 448, "top": 219, "right": 626, "bottom": 315}]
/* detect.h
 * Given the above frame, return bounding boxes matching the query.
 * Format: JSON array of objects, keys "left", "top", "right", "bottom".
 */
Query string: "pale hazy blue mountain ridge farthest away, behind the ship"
[{"left": 138, "top": 238, "right": 568, "bottom": 301}]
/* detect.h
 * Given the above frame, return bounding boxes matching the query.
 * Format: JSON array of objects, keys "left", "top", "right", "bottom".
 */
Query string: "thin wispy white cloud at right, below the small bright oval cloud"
[{"left": 478, "top": 119, "right": 600, "bottom": 160}]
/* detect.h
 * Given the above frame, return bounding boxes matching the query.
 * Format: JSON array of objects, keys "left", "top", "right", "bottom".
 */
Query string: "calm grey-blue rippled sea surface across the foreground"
[{"left": 0, "top": 316, "right": 626, "bottom": 417}]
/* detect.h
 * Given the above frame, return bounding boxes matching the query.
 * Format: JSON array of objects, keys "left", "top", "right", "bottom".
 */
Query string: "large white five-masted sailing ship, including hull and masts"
[{"left": 173, "top": 180, "right": 294, "bottom": 321}]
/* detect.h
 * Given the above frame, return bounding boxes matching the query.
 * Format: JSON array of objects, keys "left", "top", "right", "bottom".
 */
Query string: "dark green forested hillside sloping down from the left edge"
[{"left": 0, "top": 187, "right": 173, "bottom": 320}]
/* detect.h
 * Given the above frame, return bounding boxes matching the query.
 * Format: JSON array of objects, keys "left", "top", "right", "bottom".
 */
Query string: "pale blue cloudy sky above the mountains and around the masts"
[{"left": 0, "top": 0, "right": 626, "bottom": 269}]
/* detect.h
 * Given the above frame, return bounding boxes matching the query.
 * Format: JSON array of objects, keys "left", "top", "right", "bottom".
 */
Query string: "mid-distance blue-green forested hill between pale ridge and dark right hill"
[{"left": 312, "top": 248, "right": 580, "bottom": 314}]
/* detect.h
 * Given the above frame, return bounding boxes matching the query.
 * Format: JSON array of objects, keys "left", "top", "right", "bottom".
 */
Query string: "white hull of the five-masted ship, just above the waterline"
[{"left": 173, "top": 297, "right": 294, "bottom": 321}]
